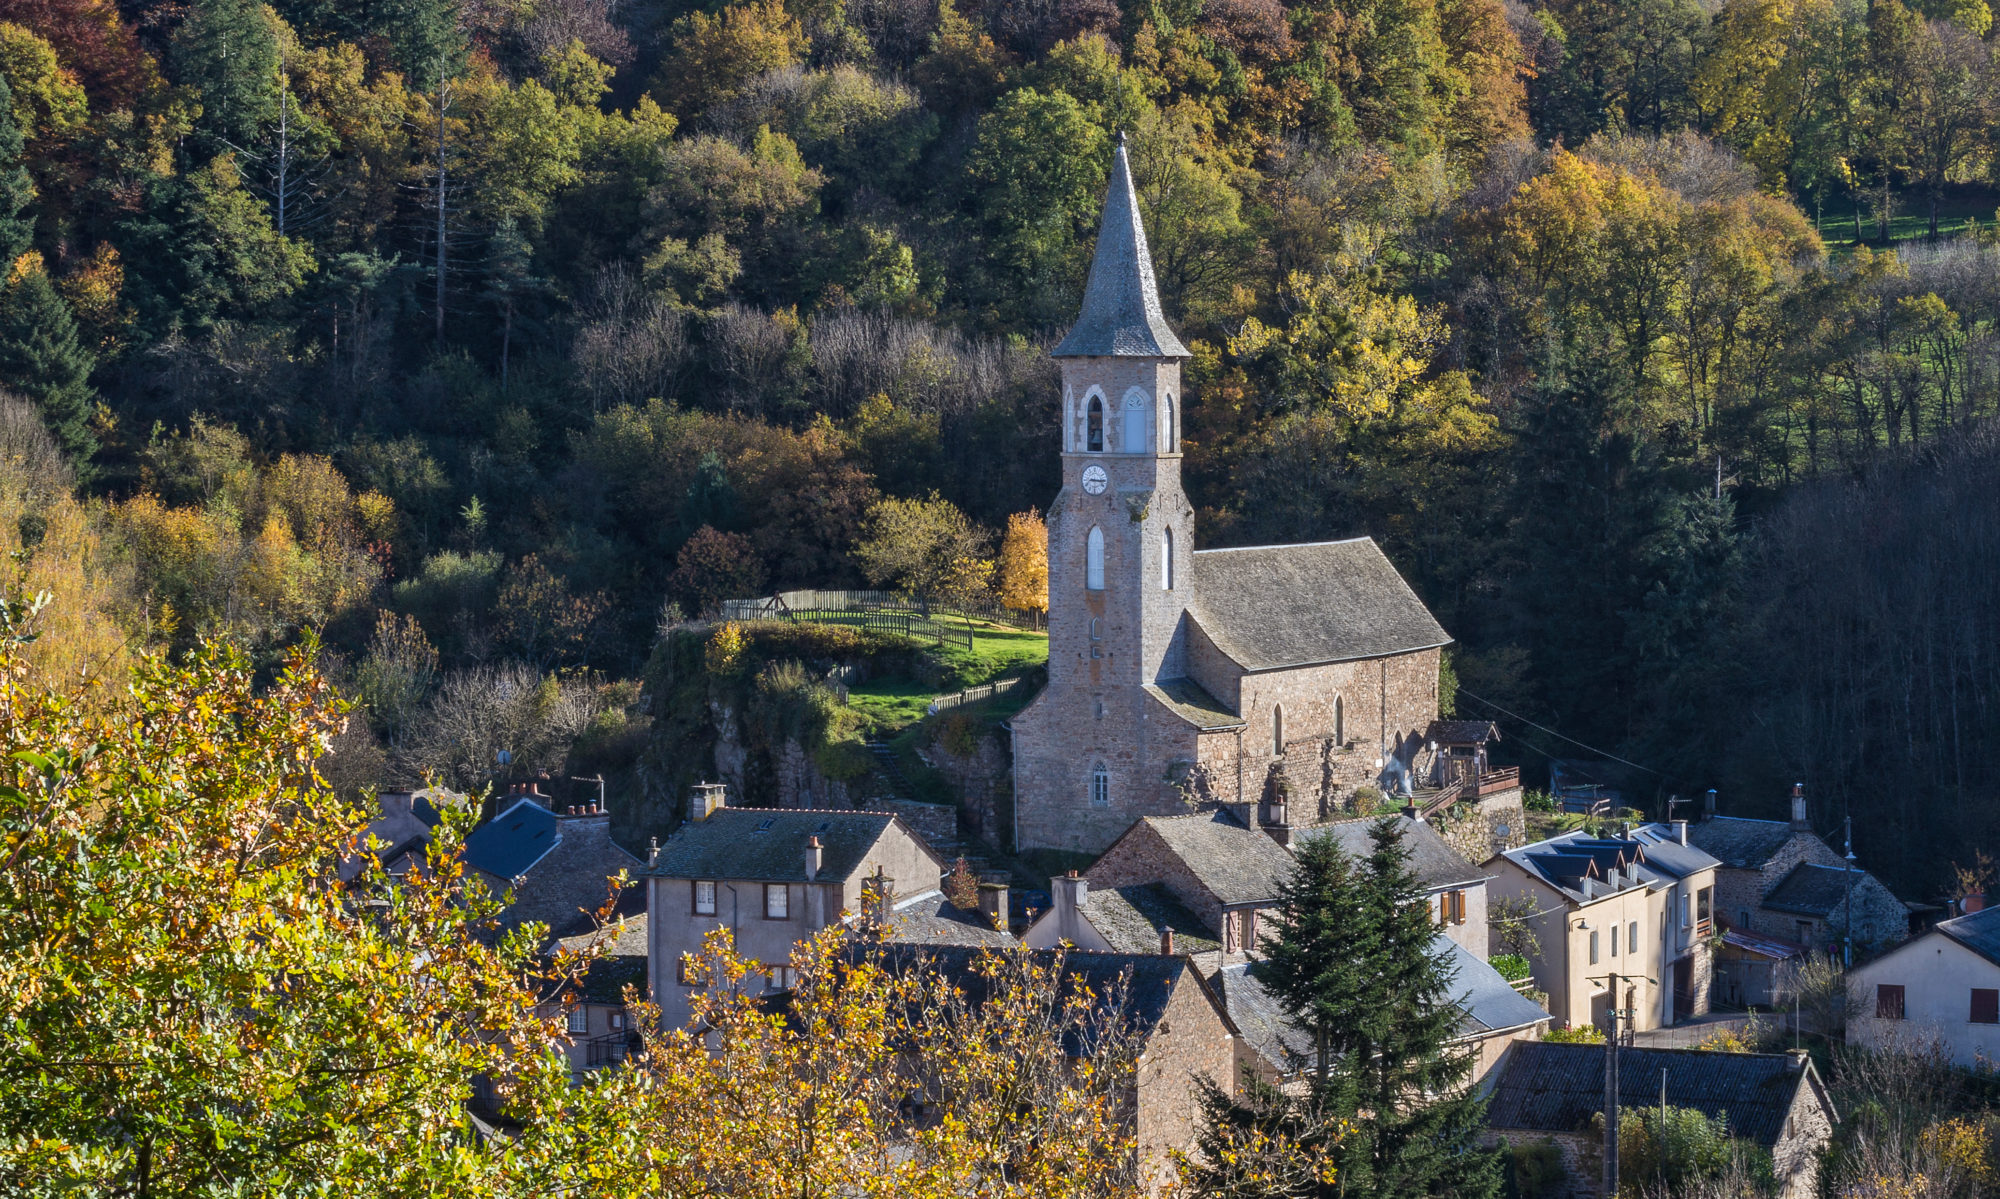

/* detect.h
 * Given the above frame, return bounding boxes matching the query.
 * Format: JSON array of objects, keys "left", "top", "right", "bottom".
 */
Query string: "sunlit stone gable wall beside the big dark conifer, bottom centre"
[{"left": 1136, "top": 967, "right": 1236, "bottom": 1193}]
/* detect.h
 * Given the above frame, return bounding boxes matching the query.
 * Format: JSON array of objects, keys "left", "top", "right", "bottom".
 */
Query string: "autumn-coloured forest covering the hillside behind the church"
[{"left": 0, "top": 0, "right": 2000, "bottom": 895}]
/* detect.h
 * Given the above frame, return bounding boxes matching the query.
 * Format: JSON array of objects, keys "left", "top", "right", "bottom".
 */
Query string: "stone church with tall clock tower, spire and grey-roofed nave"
[{"left": 1012, "top": 138, "right": 1450, "bottom": 853}]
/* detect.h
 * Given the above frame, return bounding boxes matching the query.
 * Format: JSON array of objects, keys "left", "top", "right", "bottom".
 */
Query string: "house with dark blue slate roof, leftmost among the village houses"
[{"left": 464, "top": 783, "right": 642, "bottom": 935}]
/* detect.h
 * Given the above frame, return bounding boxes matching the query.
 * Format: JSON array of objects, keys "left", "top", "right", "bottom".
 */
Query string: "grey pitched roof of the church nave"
[{"left": 1190, "top": 538, "right": 1452, "bottom": 671}]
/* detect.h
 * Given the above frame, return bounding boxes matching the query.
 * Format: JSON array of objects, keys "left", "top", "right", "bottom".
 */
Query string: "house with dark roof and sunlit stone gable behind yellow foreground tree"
[{"left": 854, "top": 939, "right": 1238, "bottom": 1193}]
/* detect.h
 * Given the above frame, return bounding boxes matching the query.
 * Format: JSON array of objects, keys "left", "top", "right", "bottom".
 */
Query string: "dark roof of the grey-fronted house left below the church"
[{"left": 644, "top": 807, "right": 944, "bottom": 883}]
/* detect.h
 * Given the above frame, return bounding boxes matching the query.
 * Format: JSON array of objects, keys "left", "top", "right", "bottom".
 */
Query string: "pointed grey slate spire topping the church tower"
[{"left": 1054, "top": 134, "right": 1188, "bottom": 358}]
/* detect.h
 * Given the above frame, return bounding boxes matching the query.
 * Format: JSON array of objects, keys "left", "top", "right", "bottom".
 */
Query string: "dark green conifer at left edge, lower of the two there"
[{"left": 0, "top": 252, "right": 98, "bottom": 462}]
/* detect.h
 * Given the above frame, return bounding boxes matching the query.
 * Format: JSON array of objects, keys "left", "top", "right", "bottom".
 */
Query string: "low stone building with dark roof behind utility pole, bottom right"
[{"left": 1486, "top": 1041, "right": 1840, "bottom": 1199}]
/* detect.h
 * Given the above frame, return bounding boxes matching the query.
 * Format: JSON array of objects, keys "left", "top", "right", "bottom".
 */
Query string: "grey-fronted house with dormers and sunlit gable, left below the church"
[{"left": 640, "top": 783, "right": 948, "bottom": 1027}]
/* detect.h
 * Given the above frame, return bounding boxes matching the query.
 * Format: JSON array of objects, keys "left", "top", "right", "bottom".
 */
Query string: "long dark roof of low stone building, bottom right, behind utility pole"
[{"left": 1486, "top": 1041, "right": 1832, "bottom": 1149}]
